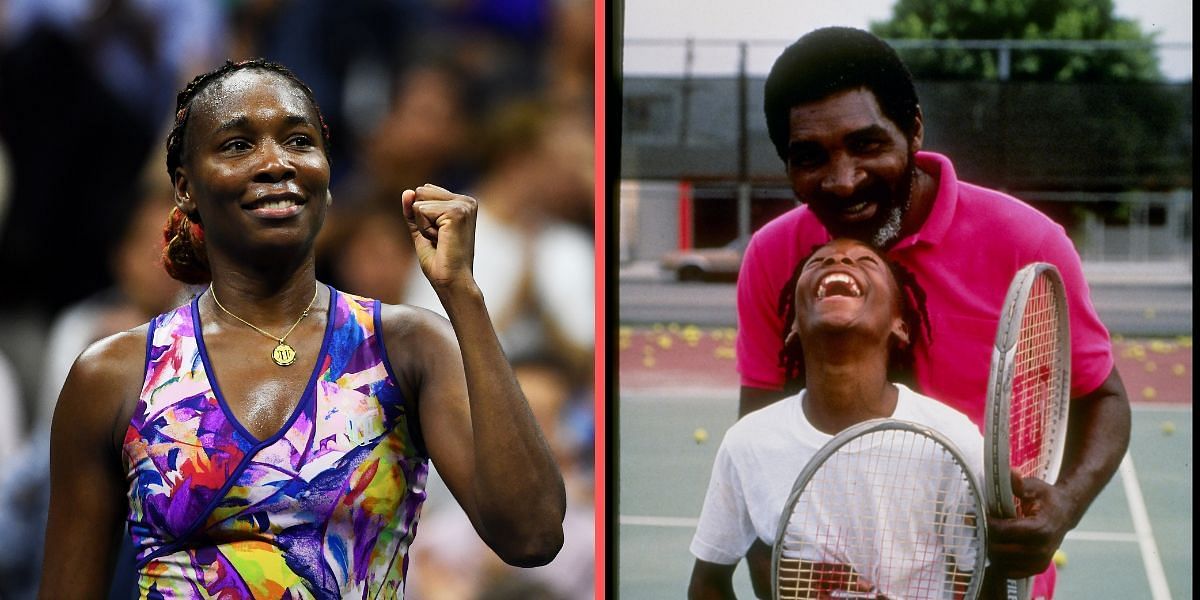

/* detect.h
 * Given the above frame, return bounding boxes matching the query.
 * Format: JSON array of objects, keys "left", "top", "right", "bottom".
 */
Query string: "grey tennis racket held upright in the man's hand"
[{"left": 984, "top": 263, "right": 1070, "bottom": 600}]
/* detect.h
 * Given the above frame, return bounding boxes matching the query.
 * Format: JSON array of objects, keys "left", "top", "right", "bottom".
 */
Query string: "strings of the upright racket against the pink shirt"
[{"left": 1009, "top": 275, "right": 1067, "bottom": 489}]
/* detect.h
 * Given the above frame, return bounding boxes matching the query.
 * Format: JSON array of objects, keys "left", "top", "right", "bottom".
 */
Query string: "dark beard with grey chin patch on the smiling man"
[{"left": 808, "top": 156, "right": 917, "bottom": 250}]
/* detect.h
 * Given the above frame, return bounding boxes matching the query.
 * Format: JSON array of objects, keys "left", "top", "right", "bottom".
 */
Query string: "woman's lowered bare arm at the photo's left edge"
[{"left": 40, "top": 326, "right": 145, "bottom": 599}]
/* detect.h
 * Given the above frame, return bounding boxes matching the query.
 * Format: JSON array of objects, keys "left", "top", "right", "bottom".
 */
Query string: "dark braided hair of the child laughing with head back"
[{"left": 775, "top": 244, "right": 934, "bottom": 394}]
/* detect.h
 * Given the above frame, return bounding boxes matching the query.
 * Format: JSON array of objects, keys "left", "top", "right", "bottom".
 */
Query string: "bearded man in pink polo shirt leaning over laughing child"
[{"left": 737, "top": 28, "right": 1129, "bottom": 598}]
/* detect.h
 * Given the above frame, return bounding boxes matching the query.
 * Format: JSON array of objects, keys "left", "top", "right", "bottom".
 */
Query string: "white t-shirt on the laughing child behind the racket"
[{"left": 690, "top": 384, "right": 983, "bottom": 565}]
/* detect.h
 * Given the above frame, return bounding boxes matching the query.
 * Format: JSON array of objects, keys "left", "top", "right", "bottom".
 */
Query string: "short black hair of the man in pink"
[{"left": 763, "top": 28, "right": 918, "bottom": 162}]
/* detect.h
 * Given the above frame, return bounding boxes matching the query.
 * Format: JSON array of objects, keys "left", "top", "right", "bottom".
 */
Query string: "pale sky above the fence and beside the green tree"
[{"left": 624, "top": 0, "right": 1192, "bottom": 80}]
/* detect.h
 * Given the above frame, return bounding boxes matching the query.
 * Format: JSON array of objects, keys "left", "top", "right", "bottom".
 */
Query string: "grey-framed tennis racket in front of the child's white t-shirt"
[{"left": 770, "top": 419, "right": 986, "bottom": 600}]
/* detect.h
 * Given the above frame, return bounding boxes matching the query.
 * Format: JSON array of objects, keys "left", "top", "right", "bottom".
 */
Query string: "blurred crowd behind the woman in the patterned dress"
[{"left": 0, "top": 0, "right": 595, "bottom": 600}]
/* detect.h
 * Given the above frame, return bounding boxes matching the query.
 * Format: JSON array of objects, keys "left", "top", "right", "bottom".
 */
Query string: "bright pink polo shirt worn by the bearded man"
[{"left": 737, "top": 152, "right": 1112, "bottom": 430}]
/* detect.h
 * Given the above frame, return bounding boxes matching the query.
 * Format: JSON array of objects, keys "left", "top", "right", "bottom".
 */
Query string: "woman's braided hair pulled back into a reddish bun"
[{"left": 162, "top": 59, "right": 330, "bottom": 284}]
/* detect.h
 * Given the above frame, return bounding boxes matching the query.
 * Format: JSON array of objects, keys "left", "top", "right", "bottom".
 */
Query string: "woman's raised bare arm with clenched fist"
[{"left": 389, "top": 186, "right": 566, "bottom": 566}]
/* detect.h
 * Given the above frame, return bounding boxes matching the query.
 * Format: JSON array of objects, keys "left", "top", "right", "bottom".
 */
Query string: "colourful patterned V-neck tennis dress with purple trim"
[{"left": 124, "top": 288, "right": 428, "bottom": 599}]
